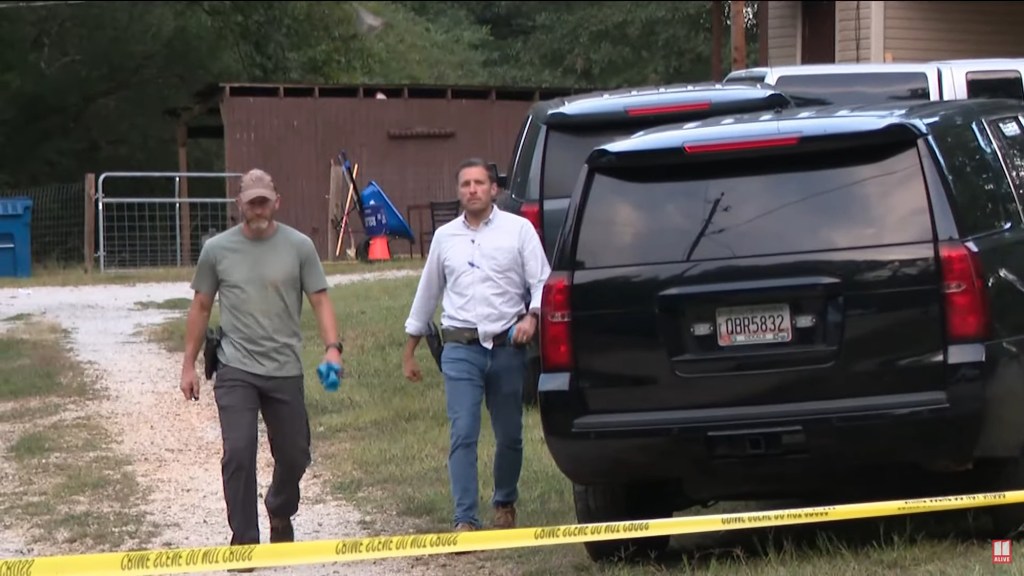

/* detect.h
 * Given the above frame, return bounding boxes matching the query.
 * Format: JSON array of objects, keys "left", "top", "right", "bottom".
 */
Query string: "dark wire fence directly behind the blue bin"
[{"left": 0, "top": 181, "right": 85, "bottom": 266}]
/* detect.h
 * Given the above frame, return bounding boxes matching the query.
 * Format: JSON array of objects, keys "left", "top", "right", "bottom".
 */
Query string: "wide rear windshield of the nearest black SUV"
[{"left": 575, "top": 145, "right": 932, "bottom": 269}]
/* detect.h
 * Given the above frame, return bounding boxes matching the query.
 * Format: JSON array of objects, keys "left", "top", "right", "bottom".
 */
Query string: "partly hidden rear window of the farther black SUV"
[{"left": 544, "top": 126, "right": 645, "bottom": 198}]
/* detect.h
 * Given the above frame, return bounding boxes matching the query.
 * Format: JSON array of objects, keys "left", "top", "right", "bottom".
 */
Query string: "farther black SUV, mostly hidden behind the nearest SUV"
[{"left": 493, "top": 84, "right": 793, "bottom": 404}]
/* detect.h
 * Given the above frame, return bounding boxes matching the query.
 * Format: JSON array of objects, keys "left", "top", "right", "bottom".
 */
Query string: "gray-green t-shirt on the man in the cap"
[{"left": 191, "top": 222, "right": 328, "bottom": 376}]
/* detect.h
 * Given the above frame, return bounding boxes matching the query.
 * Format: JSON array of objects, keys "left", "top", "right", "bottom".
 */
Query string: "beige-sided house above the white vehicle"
[{"left": 760, "top": 0, "right": 1024, "bottom": 66}]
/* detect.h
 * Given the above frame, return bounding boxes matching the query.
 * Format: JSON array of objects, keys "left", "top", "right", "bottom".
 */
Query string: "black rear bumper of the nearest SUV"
[{"left": 541, "top": 375, "right": 985, "bottom": 501}]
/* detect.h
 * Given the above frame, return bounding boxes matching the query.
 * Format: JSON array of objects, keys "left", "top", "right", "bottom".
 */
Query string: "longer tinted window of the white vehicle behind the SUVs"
[{"left": 775, "top": 72, "right": 931, "bottom": 106}]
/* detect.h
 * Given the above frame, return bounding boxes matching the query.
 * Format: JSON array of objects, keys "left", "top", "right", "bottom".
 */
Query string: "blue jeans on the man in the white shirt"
[{"left": 441, "top": 342, "right": 526, "bottom": 528}]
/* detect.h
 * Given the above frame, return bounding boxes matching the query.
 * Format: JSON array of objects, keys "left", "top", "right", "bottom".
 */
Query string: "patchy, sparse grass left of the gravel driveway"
[{"left": 0, "top": 321, "right": 152, "bottom": 552}]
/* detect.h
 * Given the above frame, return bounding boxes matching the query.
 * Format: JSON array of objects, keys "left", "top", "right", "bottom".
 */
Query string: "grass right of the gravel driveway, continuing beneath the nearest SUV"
[{"left": 152, "top": 270, "right": 1019, "bottom": 576}]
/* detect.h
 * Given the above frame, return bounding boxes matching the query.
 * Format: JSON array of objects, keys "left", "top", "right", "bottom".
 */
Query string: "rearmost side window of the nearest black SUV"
[{"left": 932, "top": 117, "right": 1021, "bottom": 237}]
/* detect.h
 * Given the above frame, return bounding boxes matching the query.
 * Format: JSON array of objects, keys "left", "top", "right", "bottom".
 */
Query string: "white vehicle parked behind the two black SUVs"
[{"left": 724, "top": 58, "right": 1024, "bottom": 106}]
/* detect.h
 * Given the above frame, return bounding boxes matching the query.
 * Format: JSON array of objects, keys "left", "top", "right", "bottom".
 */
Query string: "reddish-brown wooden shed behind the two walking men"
[{"left": 167, "top": 84, "right": 587, "bottom": 259}]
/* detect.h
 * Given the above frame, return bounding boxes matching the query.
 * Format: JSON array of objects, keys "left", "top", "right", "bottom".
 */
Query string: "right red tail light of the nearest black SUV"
[{"left": 939, "top": 242, "right": 989, "bottom": 342}]
